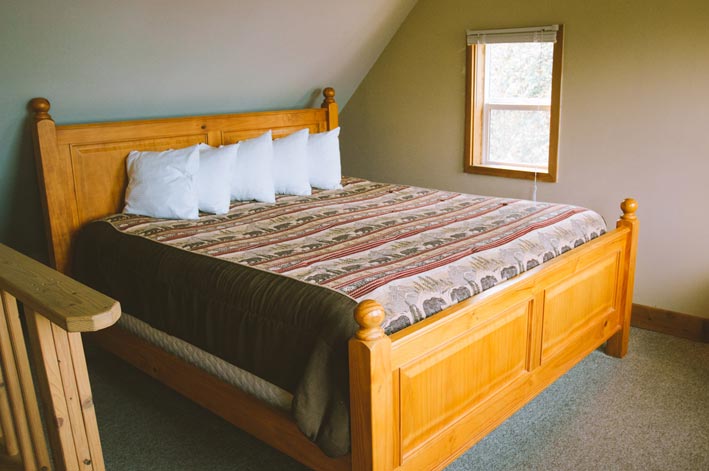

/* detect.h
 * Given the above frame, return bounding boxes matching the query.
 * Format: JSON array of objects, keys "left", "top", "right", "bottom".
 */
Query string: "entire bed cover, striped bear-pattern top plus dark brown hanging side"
[{"left": 74, "top": 178, "right": 606, "bottom": 456}]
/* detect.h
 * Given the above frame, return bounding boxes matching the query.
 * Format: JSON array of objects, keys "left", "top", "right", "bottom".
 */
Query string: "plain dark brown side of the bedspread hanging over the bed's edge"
[{"left": 74, "top": 225, "right": 357, "bottom": 456}]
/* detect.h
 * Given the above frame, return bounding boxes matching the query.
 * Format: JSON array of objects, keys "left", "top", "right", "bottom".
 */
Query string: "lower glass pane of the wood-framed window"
[{"left": 487, "top": 109, "right": 549, "bottom": 169}]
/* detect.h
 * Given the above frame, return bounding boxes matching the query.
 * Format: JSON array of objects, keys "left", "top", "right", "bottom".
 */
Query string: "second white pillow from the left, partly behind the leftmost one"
[{"left": 197, "top": 143, "right": 239, "bottom": 214}]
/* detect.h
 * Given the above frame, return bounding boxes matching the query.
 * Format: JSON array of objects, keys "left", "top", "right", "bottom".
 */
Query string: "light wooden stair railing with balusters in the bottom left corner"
[{"left": 0, "top": 244, "right": 121, "bottom": 471}]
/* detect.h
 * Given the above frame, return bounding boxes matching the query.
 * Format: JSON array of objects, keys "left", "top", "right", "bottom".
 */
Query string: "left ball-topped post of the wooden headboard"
[{"left": 29, "top": 98, "right": 78, "bottom": 273}]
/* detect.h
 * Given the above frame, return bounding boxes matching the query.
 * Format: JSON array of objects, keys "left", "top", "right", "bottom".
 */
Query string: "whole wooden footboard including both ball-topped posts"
[{"left": 350, "top": 200, "right": 638, "bottom": 470}]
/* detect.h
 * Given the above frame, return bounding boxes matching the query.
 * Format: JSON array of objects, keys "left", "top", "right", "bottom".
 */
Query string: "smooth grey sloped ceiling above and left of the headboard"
[{"left": 0, "top": 0, "right": 416, "bottom": 258}]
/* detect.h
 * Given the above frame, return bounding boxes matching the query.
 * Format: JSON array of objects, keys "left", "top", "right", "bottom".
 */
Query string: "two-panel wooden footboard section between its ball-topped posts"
[{"left": 366, "top": 228, "right": 631, "bottom": 470}]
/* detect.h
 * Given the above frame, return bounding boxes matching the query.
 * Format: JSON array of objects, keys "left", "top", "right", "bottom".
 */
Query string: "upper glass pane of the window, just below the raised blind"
[{"left": 485, "top": 43, "right": 554, "bottom": 103}]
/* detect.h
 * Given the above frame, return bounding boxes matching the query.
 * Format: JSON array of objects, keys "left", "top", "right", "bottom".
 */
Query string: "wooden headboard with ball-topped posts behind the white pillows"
[{"left": 30, "top": 88, "right": 337, "bottom": 273}]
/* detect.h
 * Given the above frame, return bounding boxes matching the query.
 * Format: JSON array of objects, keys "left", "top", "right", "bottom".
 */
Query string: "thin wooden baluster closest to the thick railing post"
[{"left": 0, "top": 293, "right": 51, "bottom": 470}]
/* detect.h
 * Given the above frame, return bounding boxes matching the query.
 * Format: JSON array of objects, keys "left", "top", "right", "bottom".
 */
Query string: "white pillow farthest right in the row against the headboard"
[{"left": 308, "top": 127, "right": 342, "bottom": 190}]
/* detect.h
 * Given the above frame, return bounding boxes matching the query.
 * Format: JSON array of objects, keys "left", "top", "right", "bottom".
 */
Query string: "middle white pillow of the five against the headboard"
[{"left": 231, "top": 131, "right": 276, "bottom": 203}]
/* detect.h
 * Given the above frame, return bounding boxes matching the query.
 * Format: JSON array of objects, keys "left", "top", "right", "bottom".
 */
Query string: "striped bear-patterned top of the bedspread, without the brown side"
[{"left": 106, "top": 178, "right": 606, "bottom": 333}]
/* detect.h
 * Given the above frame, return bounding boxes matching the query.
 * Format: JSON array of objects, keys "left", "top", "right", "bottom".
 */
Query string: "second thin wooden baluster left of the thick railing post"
[{"left": 0, "top": 291, "right": 37, "bottom": 471}]
